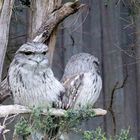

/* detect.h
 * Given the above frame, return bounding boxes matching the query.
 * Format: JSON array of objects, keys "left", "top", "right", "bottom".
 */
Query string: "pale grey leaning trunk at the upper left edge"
[{"left": 0, "top": 0, "right": 14, "bottom": 81}]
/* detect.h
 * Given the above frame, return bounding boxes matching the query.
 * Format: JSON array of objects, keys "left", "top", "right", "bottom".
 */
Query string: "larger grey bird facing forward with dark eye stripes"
[{"left": 7, "top": 42, "right": 65, "bottom": 107}]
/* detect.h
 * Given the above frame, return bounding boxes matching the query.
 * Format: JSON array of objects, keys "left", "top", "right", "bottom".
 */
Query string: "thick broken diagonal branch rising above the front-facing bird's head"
[{"left": 33, "top": 0, "right": 84, "bottom": 42}]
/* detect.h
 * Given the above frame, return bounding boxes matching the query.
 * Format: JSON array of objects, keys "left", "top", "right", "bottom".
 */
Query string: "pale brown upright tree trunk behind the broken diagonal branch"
[{"left": 29, "top": 0, "right": 62, "bottom": 65}]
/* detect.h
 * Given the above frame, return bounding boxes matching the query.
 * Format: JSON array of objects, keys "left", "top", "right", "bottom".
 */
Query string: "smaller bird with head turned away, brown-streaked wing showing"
[{"left": 61, "top": 53, "right": 102, "bottom": 109}]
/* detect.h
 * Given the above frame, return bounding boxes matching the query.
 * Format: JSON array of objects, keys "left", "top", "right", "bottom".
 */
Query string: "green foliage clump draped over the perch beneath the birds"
[{"left": 15, "top": 108, "right": 95, "bottom": 137}]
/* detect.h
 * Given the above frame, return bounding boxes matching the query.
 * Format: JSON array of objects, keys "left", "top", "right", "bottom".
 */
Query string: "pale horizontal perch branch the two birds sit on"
[{"left": 0, "top": 105, "right": 107, "bottom": 118}]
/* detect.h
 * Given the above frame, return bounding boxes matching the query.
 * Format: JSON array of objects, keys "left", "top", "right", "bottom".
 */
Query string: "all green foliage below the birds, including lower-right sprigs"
[{"left": 15, "top": 107, "right": 134, "bottom": 140}]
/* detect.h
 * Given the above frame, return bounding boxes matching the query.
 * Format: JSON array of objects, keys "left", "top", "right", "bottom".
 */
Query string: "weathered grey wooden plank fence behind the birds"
[{"left": 3, "top": 0, "right": 140, "bottom": 140}]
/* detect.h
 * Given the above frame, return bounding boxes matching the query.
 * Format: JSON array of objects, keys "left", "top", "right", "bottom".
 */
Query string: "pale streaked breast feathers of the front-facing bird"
[{"left": 9, "top": 66, "right": 64, "bottom": 107}]
